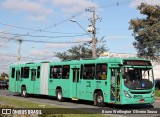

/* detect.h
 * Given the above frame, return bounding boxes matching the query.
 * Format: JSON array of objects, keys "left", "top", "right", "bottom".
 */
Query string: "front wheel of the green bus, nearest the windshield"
[{"left": 96, "top": 91, "right": 105, "bottom": 107}]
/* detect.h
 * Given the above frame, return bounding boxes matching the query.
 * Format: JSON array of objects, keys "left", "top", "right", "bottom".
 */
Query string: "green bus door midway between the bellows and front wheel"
[{"left": 71, "top": 68, "right": 80, "bottom": 98}]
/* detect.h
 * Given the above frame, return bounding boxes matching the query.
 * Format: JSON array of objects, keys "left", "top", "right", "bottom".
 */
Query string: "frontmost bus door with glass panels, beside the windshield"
[{"left": 110, "top": 68, "right": 120, "bottom": 103}]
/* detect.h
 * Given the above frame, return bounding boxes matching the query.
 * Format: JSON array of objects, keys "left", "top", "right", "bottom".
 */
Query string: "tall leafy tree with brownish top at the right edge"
[{"left": 129, "top": 3, "right": 160, "bottom": 60}]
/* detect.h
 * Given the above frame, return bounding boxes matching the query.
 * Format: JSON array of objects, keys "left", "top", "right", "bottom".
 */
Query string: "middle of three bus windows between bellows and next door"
[{"left": 53, "top": 66, "right": 62, "bottom": 79}]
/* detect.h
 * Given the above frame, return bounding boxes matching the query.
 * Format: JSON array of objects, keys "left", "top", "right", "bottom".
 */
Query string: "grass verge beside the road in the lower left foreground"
[{"left": 0, "top": 96, "right": 111, "bottom": 117}]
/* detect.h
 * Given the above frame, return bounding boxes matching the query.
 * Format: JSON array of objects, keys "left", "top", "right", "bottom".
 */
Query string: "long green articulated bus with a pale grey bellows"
[{"left": 9, "top": 58, "right": 155, "bottom": 106}]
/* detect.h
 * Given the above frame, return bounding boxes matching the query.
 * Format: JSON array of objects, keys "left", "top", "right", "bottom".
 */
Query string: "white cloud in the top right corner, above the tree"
[{"left": 130, "top": 0, "right": 160, "bottom": 7}]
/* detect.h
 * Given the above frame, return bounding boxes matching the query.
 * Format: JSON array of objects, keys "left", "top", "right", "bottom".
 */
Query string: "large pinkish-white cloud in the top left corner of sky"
[{"left": 1, "top": 0, "right": 53, "bottom": 20}]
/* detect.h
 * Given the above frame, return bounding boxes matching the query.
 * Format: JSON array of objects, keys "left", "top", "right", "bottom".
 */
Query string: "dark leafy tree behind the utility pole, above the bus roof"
[{"left": 56, "top": 38, "right": 108, "bottom": 60}]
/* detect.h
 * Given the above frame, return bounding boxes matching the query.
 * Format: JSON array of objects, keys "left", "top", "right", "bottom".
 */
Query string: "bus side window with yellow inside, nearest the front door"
[{"left": 96, "top": 63, "right": 107, "bottom": 80}]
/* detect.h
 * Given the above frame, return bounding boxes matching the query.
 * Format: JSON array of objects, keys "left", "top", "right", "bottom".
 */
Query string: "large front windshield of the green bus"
[{"left": 122, "top": 67, "right": 153, "bottom": 90}]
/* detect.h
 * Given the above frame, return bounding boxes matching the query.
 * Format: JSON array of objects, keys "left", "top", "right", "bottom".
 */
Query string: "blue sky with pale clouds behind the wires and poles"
[{"left": 0, "top": 0, "right": 160, "bottom": 73}]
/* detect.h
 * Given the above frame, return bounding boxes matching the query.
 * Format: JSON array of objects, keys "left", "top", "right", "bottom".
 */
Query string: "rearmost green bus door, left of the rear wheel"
[{"left": 15, "top": 69, "right": 21, "bottom": 92}]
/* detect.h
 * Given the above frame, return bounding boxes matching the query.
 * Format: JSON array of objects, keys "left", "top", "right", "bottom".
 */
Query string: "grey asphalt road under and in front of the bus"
[{"left": 0, "top": 90, "right": 160, "bottom": 117}]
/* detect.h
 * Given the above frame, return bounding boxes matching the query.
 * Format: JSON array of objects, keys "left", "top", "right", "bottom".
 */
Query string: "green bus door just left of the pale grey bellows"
[{"left": 30, "top": 68, "right": 36, "bottom": 93}]
